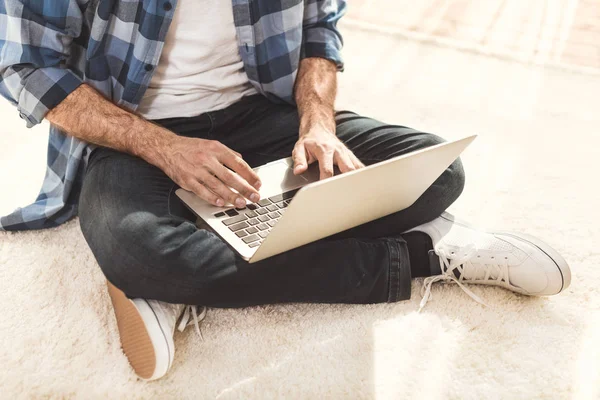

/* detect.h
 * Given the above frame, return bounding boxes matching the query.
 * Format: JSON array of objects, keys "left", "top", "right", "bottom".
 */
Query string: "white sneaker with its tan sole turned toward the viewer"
[{"left": 107, "top": 282, "right": 206, "bottom": 381}]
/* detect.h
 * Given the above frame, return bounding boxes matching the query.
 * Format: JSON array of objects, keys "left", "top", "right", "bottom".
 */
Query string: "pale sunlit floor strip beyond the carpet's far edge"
[{"left": 348, "top": 0, "right": 600, "bottom": 69}]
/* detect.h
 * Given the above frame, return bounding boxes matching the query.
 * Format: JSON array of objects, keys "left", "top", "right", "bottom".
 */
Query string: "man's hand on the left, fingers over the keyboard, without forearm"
[{"left": 161, "top": 136, "right": 261, "bottom": 208}]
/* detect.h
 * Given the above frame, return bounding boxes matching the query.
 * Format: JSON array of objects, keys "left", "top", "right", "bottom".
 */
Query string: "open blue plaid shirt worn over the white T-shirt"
[{"left": 0, "top": 0, "right": 346, "bottom": 230}]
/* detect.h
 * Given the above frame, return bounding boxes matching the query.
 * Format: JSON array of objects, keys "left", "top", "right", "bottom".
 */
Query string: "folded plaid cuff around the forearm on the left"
[{"left": 18, "top": 67, "right": 83, "bottom": 128}]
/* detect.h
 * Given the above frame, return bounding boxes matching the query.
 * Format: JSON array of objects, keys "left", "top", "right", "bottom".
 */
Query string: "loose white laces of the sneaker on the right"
[{"left": 419, "top": 246, "right": 508, "bottom": 312}]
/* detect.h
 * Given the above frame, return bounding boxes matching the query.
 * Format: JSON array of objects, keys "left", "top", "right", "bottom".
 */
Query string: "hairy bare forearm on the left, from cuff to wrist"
[{"left": 46, "top": 84, "right": 175, "bottom": 168}]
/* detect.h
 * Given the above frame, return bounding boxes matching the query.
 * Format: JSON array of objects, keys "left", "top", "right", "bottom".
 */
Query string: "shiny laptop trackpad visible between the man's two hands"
[{"left": 256, "top": 159, "right": 318, "bottom": 196}]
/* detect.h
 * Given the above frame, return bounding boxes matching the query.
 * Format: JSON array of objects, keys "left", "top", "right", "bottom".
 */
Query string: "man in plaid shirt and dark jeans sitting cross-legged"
[{"left": 0, "top": 0, "right": 570, "bottom": 380}]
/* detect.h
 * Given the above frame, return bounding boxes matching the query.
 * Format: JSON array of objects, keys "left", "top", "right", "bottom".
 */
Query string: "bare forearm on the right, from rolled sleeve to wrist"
[{"left": 294, "top": 57, "right": 337, "bottom": 135}]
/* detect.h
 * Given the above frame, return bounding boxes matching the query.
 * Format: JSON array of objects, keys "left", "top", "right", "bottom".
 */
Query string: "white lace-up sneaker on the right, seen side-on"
[{"left": 408, "top": 213, "right": 571, "bottom": 308}]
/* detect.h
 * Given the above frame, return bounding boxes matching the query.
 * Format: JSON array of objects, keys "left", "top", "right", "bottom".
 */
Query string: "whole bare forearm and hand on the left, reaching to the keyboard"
[{"left": 46, "top": 84, "right": 260, "bottom": 207}]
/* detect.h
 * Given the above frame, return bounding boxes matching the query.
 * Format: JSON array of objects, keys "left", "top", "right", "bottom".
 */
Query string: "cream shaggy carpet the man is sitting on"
[{"left": 0, "top": 27, "right": 600, "bottom": 399}]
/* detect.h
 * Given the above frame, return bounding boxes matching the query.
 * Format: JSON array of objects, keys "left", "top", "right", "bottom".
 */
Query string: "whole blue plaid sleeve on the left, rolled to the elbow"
[{"left": 0, "top": 0, "right": 88, "bottom": 127}]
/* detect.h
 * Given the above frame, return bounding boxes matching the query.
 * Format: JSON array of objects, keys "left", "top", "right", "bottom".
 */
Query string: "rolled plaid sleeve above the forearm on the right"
[{"left": 301, "top": 0, "right": 346, "bottom": 71}]
